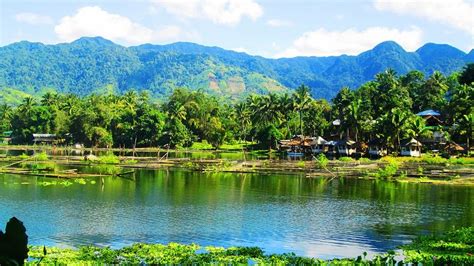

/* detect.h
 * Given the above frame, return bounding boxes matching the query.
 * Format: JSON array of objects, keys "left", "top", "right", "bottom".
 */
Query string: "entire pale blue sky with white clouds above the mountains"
[{"left": 0, "top": 0, "right": 474, "bottom": 57}]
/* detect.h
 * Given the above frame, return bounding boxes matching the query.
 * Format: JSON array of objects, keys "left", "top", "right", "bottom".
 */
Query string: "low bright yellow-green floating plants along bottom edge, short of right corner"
[{"left": 27, "top": 243, "right": 395, "bottom": 265}]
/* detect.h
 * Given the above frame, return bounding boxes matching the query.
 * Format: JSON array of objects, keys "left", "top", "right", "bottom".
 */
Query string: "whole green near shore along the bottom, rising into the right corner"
[{"left": 27, "top": 227, "right": 474, "bottom": 265}]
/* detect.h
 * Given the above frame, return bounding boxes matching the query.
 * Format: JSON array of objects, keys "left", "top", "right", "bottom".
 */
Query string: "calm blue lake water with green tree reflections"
[{"left": 0, "top": 169, "right": 474, "bottom": 258}]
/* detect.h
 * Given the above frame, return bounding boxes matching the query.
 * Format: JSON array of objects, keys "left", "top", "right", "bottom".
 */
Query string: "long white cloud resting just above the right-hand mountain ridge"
[{"left": 276, "top": 27, "right": 423, "bottom": 57}]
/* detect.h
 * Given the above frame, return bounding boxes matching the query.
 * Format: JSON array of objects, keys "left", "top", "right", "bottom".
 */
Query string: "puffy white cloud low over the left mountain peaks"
[{"left": 54, "top": 6, "right": 189, "bottom": 44}]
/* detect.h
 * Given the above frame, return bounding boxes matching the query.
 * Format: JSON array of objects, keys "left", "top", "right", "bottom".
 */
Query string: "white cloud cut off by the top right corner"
[{"left": 374, "top": 0, "right": 474, "bottom": 34}]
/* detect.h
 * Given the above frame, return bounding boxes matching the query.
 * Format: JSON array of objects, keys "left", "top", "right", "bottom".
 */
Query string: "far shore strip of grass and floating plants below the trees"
[{"left": 0, "top": 151, "right": 474, "bottom": 186}]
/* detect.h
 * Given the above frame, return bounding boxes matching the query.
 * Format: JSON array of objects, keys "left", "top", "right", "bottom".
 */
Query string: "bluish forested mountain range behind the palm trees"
[{"left": 0, "top": 37, "right": 474, "bottom": 99}]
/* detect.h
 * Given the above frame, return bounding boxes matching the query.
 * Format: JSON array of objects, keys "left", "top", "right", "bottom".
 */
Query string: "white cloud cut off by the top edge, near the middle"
[{"left": 151, "top": 0, "right": 263, "bottom": 25}]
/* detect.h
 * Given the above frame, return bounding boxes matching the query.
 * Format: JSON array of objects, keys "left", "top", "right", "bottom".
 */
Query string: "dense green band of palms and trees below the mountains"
[{"left": 0, "top": 64, "right": 474, "bottom": 148}]
